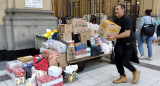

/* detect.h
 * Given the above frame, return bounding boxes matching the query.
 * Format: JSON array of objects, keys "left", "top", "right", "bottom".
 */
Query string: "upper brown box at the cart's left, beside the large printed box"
[{"left": 58, "top": 24, "right": 73, "bottom": 33}]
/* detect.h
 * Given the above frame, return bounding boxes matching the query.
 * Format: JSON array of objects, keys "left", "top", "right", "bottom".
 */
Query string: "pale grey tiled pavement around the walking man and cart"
[{"left": 0, "top": 44, "right": 160, "bottom": 86}]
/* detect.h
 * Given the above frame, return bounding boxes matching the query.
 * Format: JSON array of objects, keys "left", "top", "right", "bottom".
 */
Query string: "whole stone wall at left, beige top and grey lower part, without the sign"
[{"left": 0, "top": 0, "right": 57, "bottom": 50}]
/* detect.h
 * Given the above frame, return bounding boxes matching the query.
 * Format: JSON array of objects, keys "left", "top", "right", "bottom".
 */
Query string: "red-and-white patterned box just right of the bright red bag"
[{"left": 42, "top": 49, "right": 59, "bottom": 66}]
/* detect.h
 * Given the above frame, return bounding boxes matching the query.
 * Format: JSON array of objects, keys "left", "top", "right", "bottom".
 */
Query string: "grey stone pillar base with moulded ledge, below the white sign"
[{"left": 4, "top": 9, "right": 58, "bottom": 50}]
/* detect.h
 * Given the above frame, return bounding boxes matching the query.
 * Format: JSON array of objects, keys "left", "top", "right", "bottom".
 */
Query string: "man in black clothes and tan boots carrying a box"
[{"left": 107, "top": 4, "right": 140, "bottom": 84}]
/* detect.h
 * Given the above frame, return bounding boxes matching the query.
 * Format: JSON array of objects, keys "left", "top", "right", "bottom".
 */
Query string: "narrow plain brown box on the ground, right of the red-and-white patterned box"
[{"left": 59, "top": 53, "right": 68, "bottom": 69}]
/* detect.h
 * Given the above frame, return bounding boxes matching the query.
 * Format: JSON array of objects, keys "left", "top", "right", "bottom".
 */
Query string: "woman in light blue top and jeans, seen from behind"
[{"left": 138, "top": 9, "right": 158, "bottom": 60}]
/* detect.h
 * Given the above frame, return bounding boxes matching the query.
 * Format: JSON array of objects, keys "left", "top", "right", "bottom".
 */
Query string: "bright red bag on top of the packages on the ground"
[{"left": 33, "top": 55, "right": 49, "bottom": 71}]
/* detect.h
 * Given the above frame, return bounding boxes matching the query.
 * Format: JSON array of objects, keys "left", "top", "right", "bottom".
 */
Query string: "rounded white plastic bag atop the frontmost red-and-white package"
[{"left": 48, "top": 66, "right": 62, "bottom": 77}]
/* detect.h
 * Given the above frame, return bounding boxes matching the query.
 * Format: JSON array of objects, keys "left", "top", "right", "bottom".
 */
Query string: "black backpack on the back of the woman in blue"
[{"left": 141, "top": 18, "right": 155, "bottom": 37}]
